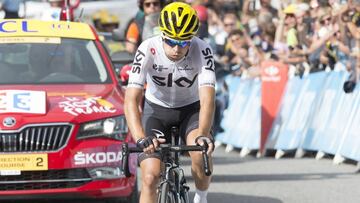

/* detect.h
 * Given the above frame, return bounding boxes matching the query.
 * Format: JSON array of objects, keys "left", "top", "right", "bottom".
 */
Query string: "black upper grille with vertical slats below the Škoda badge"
[{"left": 0, "top": 124, "right": 72, "bottom": 152}]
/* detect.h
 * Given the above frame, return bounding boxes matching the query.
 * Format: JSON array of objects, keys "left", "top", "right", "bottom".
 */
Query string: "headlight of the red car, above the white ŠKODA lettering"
[{"left": 77, "top": 116, "right": 129, "bottom": 140}]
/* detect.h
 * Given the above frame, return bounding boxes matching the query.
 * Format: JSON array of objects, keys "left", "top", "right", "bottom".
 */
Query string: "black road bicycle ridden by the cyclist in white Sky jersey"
[{"left": 122, "top": 127, "right": 211, "bottom": 203}]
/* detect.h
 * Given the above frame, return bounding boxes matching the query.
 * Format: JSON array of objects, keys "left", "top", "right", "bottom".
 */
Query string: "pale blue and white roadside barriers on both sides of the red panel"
[{"left": 216, "top": 71, "right": 360, "bottom": 164}]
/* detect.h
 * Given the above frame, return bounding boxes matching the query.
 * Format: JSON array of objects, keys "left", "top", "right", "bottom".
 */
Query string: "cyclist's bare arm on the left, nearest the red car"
[{"left": 124, "top": 88, "right": 145, "bottom": 141}]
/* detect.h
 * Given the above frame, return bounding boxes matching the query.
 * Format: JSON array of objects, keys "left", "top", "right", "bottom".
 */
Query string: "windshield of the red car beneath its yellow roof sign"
[{"left": 0, "top": 38, "right": 111, "bottom": 84}]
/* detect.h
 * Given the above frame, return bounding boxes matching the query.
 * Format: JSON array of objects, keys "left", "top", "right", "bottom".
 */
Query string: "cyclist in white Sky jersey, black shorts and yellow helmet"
[{"left": 125, "top": 2, "right": 216, "bottom": 203}]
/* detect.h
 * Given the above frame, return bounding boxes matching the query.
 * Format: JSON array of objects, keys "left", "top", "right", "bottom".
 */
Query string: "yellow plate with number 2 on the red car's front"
[{"left": 0, "top": 154, "right": 48, "bottom": 171}]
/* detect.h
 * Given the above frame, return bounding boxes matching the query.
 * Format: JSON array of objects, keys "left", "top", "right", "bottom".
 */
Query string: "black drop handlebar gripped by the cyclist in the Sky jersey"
[{"left": 121, "top": 143, "right": 212, "bottom": 177}]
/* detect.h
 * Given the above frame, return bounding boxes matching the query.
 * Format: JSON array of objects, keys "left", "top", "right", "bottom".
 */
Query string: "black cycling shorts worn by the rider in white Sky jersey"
[{"left": 139, "top": 100, "right": 200, "bottom": 162}]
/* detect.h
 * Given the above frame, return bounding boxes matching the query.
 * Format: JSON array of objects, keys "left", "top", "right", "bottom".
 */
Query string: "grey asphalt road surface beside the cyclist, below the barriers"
[{"left": 1, "top": 147, "right": 360, "bottom": 203}]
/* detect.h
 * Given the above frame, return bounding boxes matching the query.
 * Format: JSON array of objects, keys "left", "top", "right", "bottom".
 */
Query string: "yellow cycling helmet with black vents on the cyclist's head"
[{"left": 159, "top": 2, "right": 199, "bottom": 40}]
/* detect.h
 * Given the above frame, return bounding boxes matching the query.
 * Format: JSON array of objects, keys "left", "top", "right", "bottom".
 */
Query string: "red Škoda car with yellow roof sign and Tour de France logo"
[{"left": 0, "top": 20, "right": 137, "bottom": 202}]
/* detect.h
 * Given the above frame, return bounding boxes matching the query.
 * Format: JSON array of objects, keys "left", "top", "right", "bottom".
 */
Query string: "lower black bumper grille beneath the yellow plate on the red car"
[{"left": 0, "top": 168, "right": 91, "bottom": 191}]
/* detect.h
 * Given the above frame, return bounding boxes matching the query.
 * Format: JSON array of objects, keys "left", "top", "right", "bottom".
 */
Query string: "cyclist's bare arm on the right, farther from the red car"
[{"left": 199, "top": 86, "right": 215, "bottom": 136}]
